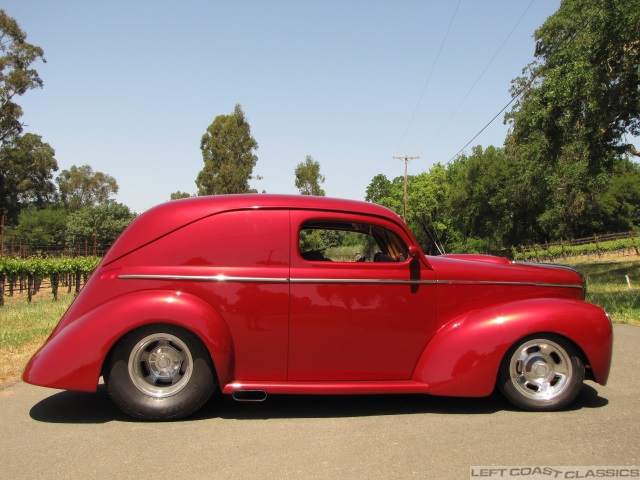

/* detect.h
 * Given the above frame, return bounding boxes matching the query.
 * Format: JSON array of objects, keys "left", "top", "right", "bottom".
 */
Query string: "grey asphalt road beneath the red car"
[{"left": 0, "top": 325, "right": 640, "bottom": 480}]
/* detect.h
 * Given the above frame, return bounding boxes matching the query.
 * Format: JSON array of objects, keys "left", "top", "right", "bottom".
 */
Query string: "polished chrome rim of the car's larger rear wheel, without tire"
[{"left": 129, "top": 333, "right": 193, "bottom": 398}]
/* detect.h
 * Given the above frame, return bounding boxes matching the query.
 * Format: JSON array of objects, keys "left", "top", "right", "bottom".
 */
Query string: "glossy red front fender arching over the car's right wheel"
[{"left": 413, "top": 298, "right": 613, "bottom": 397}]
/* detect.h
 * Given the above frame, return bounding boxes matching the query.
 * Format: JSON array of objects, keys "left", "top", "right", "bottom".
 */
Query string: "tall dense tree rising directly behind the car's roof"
[{"left": 196, "top": 105, "right": 258, "bottom": 195}]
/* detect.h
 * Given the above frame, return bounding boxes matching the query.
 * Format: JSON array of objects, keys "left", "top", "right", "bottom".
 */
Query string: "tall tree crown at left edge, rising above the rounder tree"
[{"left": 0, "top": 9, "right": 46, "bottom": 147}]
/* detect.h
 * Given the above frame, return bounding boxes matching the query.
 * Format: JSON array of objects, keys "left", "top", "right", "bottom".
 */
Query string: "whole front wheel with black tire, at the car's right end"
[{"left": 498, "top": 333, "right": 584, "bottom": 411}]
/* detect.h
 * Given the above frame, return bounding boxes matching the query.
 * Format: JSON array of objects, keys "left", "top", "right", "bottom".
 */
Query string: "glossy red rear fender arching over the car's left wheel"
[{"left": 22, "top": 290, "right": 233, "bottom": 392}]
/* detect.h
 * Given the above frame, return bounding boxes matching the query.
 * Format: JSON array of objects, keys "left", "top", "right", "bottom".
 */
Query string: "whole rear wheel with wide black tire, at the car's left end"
[{"left": 104, "top": 324, "right": 218, "bottom": 420}]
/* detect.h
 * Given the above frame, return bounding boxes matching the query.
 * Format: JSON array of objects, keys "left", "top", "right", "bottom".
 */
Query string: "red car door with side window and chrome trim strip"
[{"left": 288, "top": 211, "right": 436, "bottom": 381}]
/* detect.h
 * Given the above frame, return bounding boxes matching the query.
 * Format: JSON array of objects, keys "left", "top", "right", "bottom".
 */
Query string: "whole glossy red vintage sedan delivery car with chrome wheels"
[{"left": 24, "top": 195, "right": 613, "bottom": 420}]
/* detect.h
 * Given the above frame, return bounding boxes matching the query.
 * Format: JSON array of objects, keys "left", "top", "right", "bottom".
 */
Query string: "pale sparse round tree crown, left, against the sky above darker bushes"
[{"left": 56, "top": 165, "right": 118, "bottom": 211}]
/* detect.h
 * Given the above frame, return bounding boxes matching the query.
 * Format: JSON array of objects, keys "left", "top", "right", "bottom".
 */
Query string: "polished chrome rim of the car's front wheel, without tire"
[{"left": 509, "top": 339, "right": 573, "bottom": 400}]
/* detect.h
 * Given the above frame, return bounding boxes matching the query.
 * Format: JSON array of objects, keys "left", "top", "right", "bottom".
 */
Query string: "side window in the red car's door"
[{"left": 298, "top": 220, "right": 408, "bottom": 262}]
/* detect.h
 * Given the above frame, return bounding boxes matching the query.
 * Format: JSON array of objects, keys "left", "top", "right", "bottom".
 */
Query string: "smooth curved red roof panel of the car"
[{"left": 103, "top": 194, "right": 402, "bottom": 265}]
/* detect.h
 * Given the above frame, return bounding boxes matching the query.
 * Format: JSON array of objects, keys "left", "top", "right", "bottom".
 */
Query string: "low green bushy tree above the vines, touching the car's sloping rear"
[{"left": 67, "top": 200, "right": 136, "bottom": 246}]
